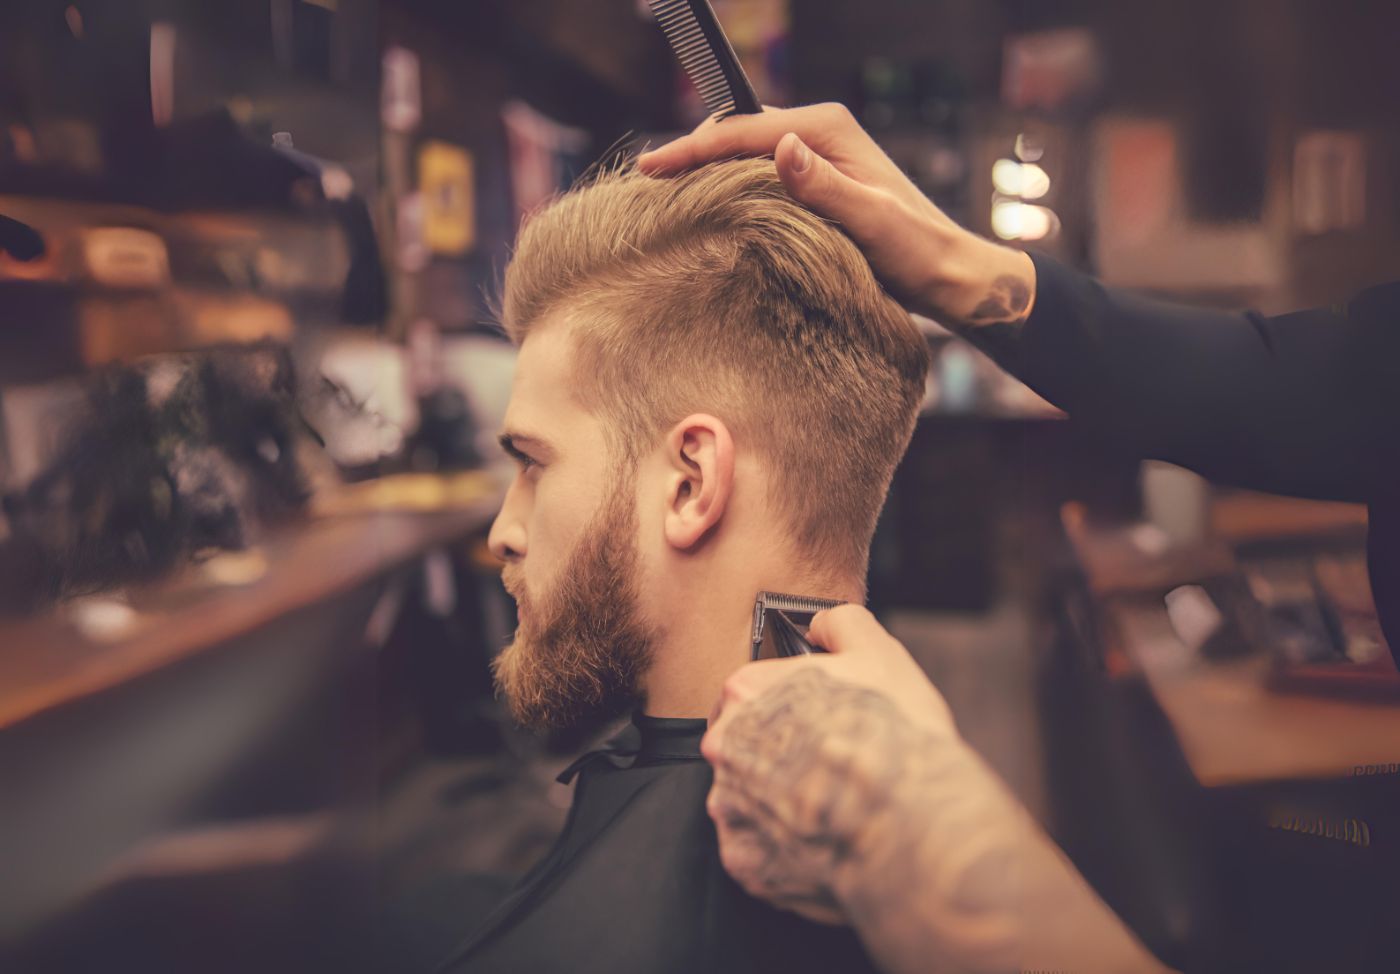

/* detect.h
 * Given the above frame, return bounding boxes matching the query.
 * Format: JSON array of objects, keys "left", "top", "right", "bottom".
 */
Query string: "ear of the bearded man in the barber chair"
[{"left": 664, "top": 413, "right": 734, "bottom": 549}]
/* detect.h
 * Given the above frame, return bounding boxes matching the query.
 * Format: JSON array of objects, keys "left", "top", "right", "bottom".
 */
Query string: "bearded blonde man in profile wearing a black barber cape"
[{"left": 436, "top": 161, "right": 928, "bottom": 974}]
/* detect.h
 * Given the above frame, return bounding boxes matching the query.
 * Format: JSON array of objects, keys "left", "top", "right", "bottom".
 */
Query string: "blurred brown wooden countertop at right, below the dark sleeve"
[{"left": 1064, "top": 491, "right": 1400, "bottom": 786}]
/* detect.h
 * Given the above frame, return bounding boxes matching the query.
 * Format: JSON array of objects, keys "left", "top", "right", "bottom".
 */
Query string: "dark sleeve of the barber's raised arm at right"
[{"left": 1008, "top": 255, "right": 1400, "bottom": 662}]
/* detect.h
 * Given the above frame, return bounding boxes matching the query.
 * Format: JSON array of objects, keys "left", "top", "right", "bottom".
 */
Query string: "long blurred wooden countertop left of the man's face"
[{"left": 0, "top": 473, "right": 501, "bottom": 731}]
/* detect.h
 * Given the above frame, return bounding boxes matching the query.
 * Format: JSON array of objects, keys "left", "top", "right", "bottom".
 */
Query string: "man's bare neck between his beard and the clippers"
[{"left": 644, "top": 581, "right": 860, "bottom": 718}]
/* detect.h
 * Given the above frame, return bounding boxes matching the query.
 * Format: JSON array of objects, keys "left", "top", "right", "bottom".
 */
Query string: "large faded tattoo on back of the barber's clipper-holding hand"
[{"left": 715, "top": 668, "right": 1025, "bottom": 970}]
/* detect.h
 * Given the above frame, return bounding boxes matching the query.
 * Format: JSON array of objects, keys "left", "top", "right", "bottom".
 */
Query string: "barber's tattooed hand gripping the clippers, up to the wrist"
[{"left": 701, "top": 605, "right": 962, "bottom": 922}]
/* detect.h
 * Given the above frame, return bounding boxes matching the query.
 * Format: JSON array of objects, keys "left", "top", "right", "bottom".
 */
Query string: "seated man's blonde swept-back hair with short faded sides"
[{"left": 501, "top": 160, "right": 928, "bottom": 575}]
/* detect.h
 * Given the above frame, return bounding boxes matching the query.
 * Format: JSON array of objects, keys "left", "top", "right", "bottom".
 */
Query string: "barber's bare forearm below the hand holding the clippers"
[{"left": 837, "top": 729, "right": 1166, "bottom": 974}]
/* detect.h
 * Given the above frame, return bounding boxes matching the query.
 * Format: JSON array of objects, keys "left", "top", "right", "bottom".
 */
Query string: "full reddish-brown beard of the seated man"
[{"left": 493, "top": 484, "right": 654, "bottom": 731}]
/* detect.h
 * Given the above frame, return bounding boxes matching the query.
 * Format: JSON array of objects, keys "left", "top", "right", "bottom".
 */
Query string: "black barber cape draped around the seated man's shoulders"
[{"left": 440, "top": 714, "right": 875, "bottom": 974}]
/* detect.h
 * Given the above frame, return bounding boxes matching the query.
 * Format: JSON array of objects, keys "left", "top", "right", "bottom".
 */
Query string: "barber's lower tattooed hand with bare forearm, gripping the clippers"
[{"left": 701, "top": 606, "right": 1165, "bottom": 974}]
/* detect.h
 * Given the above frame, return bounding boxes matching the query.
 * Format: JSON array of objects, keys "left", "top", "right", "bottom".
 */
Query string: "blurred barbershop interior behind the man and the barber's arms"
[{"left": 0, "top": 0, "right": 1400, "bottom": 973}]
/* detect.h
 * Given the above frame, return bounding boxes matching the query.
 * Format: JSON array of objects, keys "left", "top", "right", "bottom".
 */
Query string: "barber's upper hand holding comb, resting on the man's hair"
[{"left": 637, "top": 104, "right": 1036, "bottom": 327}]
